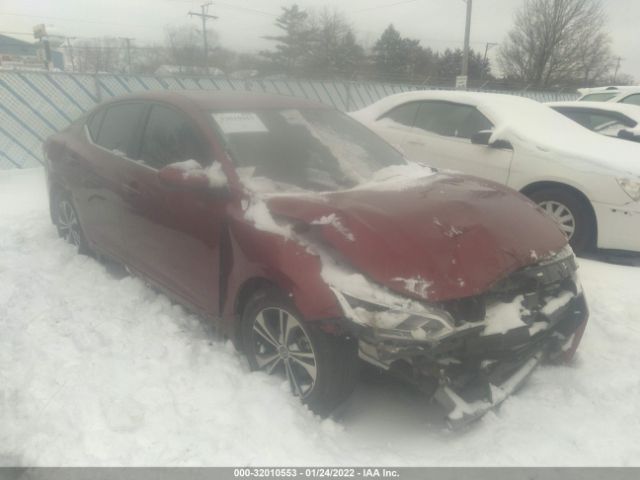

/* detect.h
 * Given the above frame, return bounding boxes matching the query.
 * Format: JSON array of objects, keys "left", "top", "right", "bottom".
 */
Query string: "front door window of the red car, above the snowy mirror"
[{"left": 140, "top": 105, "right": 207, "bottom": 169}]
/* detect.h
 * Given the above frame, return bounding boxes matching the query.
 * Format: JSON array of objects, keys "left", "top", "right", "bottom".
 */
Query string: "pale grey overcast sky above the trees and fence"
[{"left": 0, "top": 0, "right": 640, "bottom": 81}]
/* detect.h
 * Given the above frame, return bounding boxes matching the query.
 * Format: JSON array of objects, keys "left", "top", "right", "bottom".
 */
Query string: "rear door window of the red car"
[{"left": 96, "top": 103, "right": 145, "bottom": 156}]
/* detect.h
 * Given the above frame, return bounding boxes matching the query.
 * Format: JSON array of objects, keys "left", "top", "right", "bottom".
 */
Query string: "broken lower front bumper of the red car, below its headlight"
[{"left": 352, "top": 293, "right": 588, "bottom": 428}]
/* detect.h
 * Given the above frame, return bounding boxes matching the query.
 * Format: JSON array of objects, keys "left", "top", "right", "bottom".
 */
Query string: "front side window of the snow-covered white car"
[{"left": 416, "top": 102, "right": 493, "bottom": 139}]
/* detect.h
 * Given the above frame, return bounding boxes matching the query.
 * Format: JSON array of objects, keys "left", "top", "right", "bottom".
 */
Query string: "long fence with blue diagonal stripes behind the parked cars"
[{"left": 0, "top": 71, "right": 576, "bottom": 169}]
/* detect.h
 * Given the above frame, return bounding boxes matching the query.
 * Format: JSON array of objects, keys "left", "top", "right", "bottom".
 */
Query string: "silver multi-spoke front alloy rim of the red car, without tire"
[{"left": 252, "top": 308, "right": 318, "bottom": 398}]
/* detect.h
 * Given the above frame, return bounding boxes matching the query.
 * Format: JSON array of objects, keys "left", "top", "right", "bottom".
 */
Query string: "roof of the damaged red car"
[{"left": 99, "top": 90, "right": 331, "bottom": 110}]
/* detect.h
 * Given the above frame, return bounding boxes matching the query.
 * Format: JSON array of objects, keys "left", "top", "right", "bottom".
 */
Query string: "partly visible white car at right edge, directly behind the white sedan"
[{"left": 547, "top": 102, "right": 640, "bottom": 142}]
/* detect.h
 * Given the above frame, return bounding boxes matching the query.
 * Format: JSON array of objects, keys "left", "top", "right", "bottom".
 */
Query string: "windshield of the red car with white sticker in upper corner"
[{"left": 212, "top": 109, "right": 406, "bottom": 191}]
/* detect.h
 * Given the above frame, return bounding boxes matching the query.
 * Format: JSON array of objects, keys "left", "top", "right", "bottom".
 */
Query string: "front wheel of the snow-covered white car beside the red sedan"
[{"left": 529, "top": 187, "right": 595, "bottom": 253}]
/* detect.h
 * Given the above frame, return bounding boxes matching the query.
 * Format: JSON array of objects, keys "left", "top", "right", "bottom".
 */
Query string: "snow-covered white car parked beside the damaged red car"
[{"left": 352, "top": 91, "right": 640, "bottom": 252}]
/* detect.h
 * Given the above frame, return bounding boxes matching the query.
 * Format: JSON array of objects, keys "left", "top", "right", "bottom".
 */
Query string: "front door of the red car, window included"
[{"left": 115, "top": 104, "right": 226, "bottom": 315}]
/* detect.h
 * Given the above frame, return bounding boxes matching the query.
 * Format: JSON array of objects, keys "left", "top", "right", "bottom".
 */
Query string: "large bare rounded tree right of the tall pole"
[{"left": 498, "top": 0, "right": 612, "bottom": 88}]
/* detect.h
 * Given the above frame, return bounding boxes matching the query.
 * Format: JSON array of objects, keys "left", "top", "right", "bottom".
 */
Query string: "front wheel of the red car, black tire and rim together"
[{"left": 241, "top": 289, "right": 358, "bottom": 416}]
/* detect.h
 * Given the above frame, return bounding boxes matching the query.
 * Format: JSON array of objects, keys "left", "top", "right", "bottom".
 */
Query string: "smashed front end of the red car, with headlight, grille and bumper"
[{"left": 336, "top": 247, "right": 589, "bottom": 427}]
